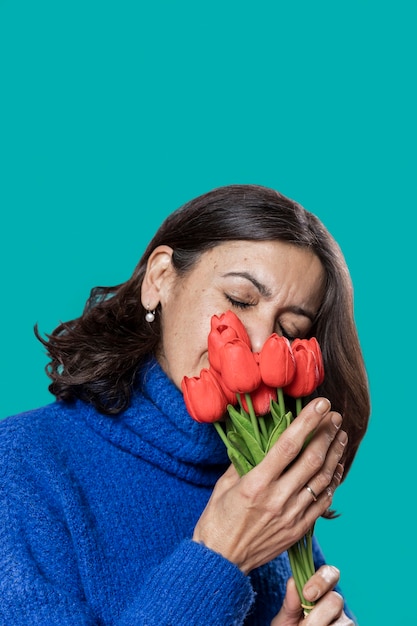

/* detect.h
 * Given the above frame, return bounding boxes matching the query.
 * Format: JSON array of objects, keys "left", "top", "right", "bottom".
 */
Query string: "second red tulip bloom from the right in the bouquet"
[{"left": 259, "top": 333, "right": 295, "bottom": 387}]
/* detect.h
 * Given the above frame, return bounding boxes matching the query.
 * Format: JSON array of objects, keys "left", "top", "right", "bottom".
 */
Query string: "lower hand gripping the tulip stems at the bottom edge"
[{"left": 271, "top": 565, "right": 354, "bottom": 626}]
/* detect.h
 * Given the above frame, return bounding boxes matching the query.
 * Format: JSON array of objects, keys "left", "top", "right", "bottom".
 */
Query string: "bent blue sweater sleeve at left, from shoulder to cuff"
[{"left": 0, "top": 424, "right": 254, "bottom": 626}]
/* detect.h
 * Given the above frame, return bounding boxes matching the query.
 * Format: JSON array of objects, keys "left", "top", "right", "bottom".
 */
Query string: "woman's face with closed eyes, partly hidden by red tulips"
[{"left": 145, "top": 241, "right": 324, "bottom": 387}]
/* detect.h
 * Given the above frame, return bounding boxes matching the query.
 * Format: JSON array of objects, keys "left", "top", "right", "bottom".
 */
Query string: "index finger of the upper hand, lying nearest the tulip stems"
[{"left": 254, "top": 398, "right": 330, "bottom": 483}]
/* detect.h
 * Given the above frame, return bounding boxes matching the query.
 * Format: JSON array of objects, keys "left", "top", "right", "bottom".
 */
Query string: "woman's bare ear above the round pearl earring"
[{"left": 141, "top": 246, "right": 175, "bottom": 310}]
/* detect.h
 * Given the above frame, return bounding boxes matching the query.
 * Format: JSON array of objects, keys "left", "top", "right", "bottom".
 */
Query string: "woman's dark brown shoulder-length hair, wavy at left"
[{"left": 35, "top": 185, "right": 370, "bottom": 474}]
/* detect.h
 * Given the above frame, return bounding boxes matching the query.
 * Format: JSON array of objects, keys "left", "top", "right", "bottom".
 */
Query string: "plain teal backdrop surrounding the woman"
[{"left": 0, "top": 0, "right": 417, "bottom": 626}]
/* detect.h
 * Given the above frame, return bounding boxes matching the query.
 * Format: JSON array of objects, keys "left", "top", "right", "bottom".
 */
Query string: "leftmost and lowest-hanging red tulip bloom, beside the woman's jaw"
[{"left": 181, "top": 369, "right": 228, "bottom": 422}]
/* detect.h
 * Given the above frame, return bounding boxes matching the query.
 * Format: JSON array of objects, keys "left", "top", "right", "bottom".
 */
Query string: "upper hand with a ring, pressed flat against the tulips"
[{"left": 193, "top": 398, "right": 347, "bottom": 574}]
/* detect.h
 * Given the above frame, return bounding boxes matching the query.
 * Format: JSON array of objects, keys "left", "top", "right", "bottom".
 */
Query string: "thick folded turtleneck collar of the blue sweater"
[{"left": 78, "top": 359, "right": 229, "bottom": 486}]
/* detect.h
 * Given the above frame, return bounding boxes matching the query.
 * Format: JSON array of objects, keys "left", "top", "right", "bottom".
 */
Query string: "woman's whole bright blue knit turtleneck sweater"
[{"left": 0, "top": 361, "right": 354, "bottom": 626}]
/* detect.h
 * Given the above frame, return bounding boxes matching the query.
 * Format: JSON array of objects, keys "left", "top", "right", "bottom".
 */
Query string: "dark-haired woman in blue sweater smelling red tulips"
[{"left": 0, "top": 185, "right": 369, "bottom": 626}]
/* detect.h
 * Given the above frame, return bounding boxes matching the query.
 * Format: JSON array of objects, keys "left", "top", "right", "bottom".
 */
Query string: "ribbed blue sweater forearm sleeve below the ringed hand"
[{"left": 118, "top": 540, "right": 254, "bottom": 626}]
